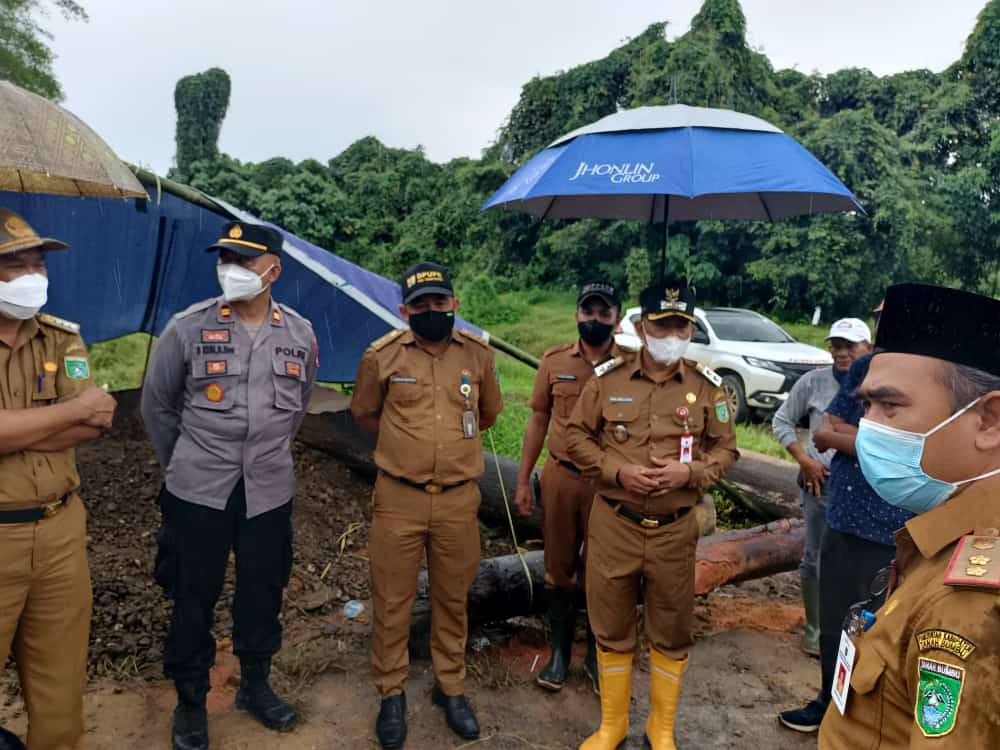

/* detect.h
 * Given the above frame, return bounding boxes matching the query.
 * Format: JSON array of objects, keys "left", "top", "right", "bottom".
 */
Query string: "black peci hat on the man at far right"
[{"left": 875, "top": 284, "right": 1000, "bottom": 375}]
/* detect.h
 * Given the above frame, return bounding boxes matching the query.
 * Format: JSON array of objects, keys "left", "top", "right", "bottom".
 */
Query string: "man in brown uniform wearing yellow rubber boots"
[{"left": 567, "top": 285, "right": 739, "bottom": 750}]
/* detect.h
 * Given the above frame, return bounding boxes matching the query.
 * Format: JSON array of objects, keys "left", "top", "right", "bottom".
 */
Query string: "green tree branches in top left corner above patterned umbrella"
[{"left": 0, "top": 0, "right": 88, "bottom": 101}]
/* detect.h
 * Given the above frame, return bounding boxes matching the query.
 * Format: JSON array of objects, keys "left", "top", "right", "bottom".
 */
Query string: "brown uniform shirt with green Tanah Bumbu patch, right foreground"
[{"left": 819, "top": 480, "right": 1000, "bottom": 750}]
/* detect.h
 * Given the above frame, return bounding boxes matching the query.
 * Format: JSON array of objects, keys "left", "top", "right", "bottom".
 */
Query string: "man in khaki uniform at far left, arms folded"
[{"left": 0, "top": 209, "right": 115, "bottom": 750}]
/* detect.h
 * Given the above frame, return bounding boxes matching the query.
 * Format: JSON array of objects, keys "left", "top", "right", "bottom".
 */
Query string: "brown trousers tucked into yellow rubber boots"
[{"left": 587, "top": 496, "right": 699, "bottom": 653}]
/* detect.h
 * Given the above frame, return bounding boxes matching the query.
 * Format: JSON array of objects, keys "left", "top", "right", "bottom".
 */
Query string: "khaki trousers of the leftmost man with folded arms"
[{"left": 0, "top": 495, "right": 93, "bottom": 750}]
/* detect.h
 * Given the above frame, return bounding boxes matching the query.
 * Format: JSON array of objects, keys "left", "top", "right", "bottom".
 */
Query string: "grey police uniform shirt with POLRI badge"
[{"left": 142, "top": 297, "right": 319, "bottom": 518}]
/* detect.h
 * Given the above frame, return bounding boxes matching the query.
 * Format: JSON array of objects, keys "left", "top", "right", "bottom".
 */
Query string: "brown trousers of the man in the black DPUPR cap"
[{"left": 368, "top": 473, "right": 479, "bottom": 698}]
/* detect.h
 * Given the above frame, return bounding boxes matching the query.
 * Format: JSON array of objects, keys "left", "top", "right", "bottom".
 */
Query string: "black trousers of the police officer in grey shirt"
[{"left": 155, "top": 480, "right": 292, "bottom": 681}]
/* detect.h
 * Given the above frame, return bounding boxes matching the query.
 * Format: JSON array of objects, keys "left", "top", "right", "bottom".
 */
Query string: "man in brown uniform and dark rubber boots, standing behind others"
[{"left": 517, "top": 279, "right": 622, "bottom": 691}]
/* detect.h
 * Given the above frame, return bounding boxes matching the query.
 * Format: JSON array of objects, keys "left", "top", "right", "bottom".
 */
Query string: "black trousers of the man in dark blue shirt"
[{"left": 819, "top": 527, "right": 896, "bottom": 704}]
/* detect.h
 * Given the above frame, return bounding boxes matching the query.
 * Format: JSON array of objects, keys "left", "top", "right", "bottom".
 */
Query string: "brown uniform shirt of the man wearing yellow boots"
[{"left": 566, "top": 352, "right": 739, "bottom": 515}]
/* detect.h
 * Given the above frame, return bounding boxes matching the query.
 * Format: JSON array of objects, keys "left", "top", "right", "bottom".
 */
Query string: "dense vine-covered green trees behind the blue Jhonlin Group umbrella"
[{"left": 170, "top": 0, "right": 1000, "bottom": 318}]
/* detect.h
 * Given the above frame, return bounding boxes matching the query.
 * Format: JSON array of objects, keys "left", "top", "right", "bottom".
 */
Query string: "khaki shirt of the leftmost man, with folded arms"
[{"left": 0, "top": 315, "right": 93, "bottom": 509}]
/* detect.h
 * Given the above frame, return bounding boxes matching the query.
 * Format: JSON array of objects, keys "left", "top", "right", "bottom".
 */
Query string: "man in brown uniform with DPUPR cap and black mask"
[{"left": 351, "top": 263, "right": 502, "bottom": 748}]
